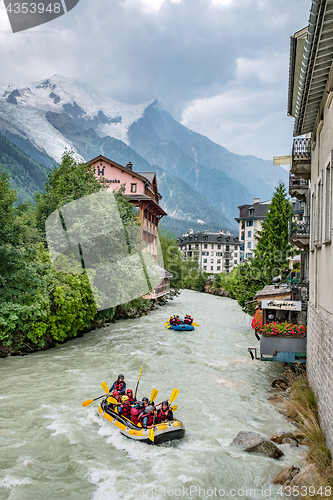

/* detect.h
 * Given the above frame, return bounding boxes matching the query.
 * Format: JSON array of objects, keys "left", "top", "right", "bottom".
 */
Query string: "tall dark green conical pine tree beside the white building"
[{"left": 251, "top": 182, "right": 293, "bottom": 284}]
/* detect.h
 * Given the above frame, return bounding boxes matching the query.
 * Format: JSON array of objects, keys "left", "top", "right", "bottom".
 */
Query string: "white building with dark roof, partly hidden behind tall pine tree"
[{"left": 235, "top": 198, "right": 271, "bottom": 261}]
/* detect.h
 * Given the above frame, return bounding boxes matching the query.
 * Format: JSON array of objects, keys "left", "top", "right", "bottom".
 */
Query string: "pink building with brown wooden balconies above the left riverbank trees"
[{"left": 89, "top": 155, "right": 172, "bottom": 299}]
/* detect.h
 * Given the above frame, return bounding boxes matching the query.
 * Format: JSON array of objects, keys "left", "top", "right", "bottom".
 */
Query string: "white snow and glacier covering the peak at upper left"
[{"left": 0, "top": 75, "right": 150, "bottom": 161}]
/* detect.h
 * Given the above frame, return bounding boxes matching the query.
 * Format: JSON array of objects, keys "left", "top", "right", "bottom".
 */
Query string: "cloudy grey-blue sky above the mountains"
[{"left": 0, "top": 0, "right": 311, "bottom": 160}]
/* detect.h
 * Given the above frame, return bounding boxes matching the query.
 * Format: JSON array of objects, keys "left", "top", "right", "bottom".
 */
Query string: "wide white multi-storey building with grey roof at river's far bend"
[{"left": 177, "top": 229, "right": 241, "bottom": 274}]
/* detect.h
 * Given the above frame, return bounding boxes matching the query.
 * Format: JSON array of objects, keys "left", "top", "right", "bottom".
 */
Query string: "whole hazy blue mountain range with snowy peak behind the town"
[{"left": 0, "top": 75, "right": 288, "bottom": 229}]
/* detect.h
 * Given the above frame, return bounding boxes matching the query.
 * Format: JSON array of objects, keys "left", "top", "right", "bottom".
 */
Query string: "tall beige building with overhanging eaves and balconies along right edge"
[{"left": 288, "top": 0, "right": 333, "bottom": 452}]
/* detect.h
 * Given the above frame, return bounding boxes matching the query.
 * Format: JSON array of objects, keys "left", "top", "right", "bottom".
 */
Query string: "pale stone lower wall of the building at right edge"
[{"left": 307, "top": 302, "right": 333, "bottom": 454}]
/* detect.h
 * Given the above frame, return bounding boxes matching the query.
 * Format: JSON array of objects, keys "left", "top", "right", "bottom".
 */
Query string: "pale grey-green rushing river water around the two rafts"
[{"left": 0, "top": 291, "right": 304, "bottom": 500}]
